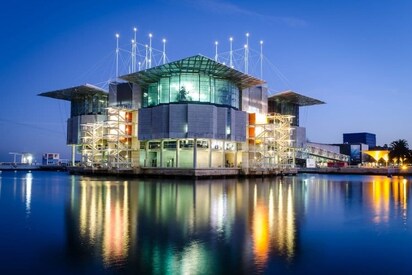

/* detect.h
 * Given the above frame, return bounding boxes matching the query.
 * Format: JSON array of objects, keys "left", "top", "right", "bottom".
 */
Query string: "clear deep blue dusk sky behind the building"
[{"left": 0, "top": 0, "right": 412, "bottom": 161}]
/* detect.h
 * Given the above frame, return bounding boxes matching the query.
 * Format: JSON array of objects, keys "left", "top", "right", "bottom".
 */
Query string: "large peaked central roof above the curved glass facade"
[{"left": 120, "top": 55, "right": 265, "bottom": 89}]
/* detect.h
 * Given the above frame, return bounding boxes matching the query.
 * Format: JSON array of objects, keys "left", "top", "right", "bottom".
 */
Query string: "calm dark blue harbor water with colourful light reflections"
[{"left": 0, "top": 171, "right": 412, "bottom": 274}]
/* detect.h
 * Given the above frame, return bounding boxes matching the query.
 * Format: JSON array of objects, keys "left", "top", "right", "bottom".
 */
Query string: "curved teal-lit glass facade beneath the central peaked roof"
[{"left": 142, "top": 73, "right": 239, "bottom": 109}]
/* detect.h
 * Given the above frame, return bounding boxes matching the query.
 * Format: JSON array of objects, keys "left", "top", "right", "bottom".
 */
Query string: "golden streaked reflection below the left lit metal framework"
[{"left": 79, "top": 181, "right": 130, "bottom": 266}]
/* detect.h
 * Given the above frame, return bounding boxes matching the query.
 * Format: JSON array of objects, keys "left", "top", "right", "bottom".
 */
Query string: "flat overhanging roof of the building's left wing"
[{"left": 39, "top": 84, "right": 108, "bottom": 101}]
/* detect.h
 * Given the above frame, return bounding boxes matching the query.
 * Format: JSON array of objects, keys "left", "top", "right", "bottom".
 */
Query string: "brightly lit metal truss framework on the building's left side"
[{"left": 81, "top": 107, "right": 138, "bottom": 169}]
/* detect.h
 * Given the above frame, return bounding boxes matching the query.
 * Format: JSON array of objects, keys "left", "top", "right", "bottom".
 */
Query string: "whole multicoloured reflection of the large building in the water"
[{"left": 68, "top": 178, "right": 304, "bottom": 274}]
